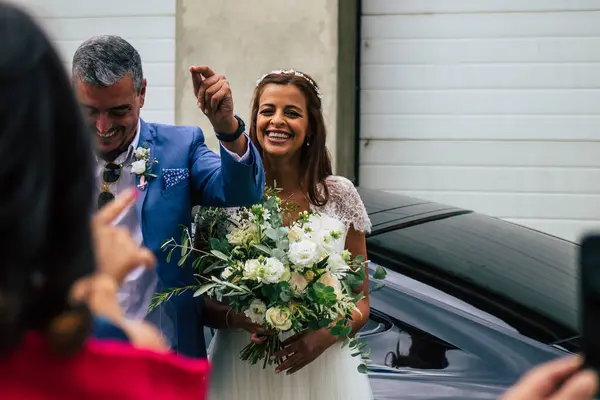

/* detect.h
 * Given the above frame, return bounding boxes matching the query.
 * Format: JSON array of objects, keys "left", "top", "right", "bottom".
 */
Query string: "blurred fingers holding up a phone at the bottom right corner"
[{"left": 501, "top": 356, "right": 598, "bottom": 400}]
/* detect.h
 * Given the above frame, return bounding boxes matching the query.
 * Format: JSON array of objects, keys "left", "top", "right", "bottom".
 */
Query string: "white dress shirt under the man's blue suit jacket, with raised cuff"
[{"left": 96, "top": 121, "right": 250, "bottom": 319}]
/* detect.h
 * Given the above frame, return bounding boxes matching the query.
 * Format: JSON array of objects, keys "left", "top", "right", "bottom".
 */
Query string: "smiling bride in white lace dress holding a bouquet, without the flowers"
[{"left": 209, "top": 70, "right": 372, "bottom": 400}]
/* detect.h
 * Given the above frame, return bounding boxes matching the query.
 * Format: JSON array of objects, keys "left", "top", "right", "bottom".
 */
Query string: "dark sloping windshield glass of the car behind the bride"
[{"left": 369, "top": 213, "right": 578, "bottom": 342}]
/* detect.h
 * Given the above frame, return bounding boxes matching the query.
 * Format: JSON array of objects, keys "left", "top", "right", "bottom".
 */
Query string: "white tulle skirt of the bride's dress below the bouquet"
[{"left": 208, "top": 330, "right": 373, "bottom": 400}]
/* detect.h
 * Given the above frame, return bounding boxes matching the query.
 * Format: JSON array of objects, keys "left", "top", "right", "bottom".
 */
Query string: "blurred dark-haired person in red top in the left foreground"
[{"left": 0, "top": 3, "right": 208, "bottom": 399}]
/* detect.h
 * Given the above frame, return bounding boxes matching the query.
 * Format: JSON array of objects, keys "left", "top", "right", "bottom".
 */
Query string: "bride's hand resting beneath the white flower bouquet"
[{"left": 274, "top": 329, "right": 338, "bottom": 375}]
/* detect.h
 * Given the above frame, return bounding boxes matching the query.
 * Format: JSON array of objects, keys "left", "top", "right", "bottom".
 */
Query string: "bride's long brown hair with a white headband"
[{"left": 250, "top": 71, "right": 332, "bottom": 206}]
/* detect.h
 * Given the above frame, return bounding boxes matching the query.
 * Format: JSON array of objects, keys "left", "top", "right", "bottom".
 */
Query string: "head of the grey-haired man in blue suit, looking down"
[{"left": 72, "top": 35, "right": 146, "bottom": 161}]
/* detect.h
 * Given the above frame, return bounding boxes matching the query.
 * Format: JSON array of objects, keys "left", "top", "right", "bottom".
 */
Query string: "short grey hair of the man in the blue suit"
[{"left": 73, "top": 35, "right": 144, "bottom": 94}]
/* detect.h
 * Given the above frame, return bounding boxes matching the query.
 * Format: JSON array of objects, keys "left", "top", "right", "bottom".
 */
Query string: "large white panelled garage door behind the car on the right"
[{"left": 359, "top": 0, "right": 600, "bottom": 240}]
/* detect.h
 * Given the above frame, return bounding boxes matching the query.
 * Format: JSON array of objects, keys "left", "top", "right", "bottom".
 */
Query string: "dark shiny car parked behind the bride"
[{"left": 207, "top": 189, "right": 579, "bottom": 400}]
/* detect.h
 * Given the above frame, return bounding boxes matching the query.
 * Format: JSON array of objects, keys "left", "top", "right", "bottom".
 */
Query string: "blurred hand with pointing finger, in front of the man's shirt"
[{"left": 92, "top": 189, "right": 156, "bottom": 285}]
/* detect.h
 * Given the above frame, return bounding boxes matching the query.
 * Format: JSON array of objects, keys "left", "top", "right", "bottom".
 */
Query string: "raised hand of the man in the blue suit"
[{"left": 190, "top": 65, "right": 238, "bottom": 134}]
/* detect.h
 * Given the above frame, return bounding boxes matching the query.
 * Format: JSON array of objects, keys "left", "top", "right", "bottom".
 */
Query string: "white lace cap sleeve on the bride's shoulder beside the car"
[{"left": 322, "top": 176, "right": 371, "bottom": 233}]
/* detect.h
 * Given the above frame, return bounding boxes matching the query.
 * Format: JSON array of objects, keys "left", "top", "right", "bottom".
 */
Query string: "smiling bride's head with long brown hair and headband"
[{"left": 250, "top": 70, "right": 332, "bottom": 206}]
